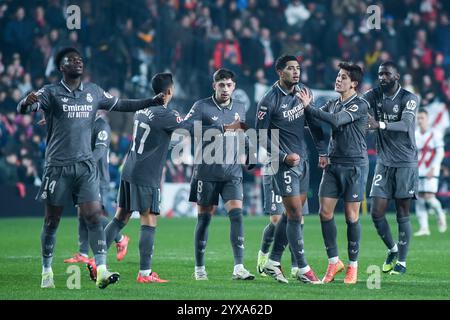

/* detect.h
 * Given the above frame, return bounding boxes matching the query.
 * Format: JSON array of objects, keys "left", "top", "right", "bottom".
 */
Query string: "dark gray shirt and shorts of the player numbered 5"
[{"left": 256, "top": 82, "right": 326, "bottom": 196}]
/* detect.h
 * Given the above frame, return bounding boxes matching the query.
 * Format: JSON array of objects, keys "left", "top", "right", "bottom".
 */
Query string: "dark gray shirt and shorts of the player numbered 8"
[{"left": 185, "top": 96, "right": 245, "bottom": 206}]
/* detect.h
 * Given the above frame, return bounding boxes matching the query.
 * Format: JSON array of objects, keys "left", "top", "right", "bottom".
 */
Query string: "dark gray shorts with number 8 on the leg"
[{"left": 189, "top": 178, "right": 244, "bottom": 206}]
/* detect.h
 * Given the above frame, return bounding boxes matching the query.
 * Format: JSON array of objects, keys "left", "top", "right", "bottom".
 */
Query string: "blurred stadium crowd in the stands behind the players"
[{"left": 0, "top": 0, "right": 450, "bottom": 205}]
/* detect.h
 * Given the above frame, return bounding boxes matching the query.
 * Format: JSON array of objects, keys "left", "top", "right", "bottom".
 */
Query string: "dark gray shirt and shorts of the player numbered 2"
[{"left": 362, "top": 87, "right": 419, "bottom": 199}]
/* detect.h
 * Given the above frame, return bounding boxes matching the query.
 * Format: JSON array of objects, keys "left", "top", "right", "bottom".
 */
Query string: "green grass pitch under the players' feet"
[{"left": 0, "top": 215, "right": 450, "bottom": 300}]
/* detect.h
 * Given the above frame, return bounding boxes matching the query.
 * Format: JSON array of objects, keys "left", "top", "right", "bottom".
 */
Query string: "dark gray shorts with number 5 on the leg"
[{"left": 273, "top": 158, "right": 309, "bottom": 197}]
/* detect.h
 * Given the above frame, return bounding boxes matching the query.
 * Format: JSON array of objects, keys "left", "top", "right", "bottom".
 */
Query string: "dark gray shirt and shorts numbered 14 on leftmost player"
[{"left": 29, "top": 80, "right": 118, "bottom": 206}]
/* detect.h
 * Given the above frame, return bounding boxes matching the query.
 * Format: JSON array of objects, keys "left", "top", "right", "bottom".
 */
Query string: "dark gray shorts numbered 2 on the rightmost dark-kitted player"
[{"left": 370, "top": 163, "right": 419, "bottom": 199}]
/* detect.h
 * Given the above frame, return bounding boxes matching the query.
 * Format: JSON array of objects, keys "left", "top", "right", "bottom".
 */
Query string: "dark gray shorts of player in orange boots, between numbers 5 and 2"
[{"left": 319, "top": 163, "right": 369, "bottom": 202}]
